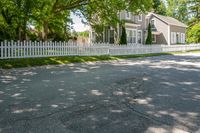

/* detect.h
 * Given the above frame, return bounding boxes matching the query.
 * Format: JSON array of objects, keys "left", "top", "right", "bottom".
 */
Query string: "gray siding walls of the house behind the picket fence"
[{"left": 90, "top": 11, "right": 186, "bottom": 45}]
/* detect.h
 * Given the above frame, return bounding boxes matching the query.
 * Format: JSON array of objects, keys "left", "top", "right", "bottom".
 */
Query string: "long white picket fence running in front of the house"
[{"left": 0, "top": 41, "right": 200, "bottom": 59}]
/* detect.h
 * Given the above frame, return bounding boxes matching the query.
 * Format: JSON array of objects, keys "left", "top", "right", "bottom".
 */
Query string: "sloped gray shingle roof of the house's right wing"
[{"left": 148, "top": 13, "right": 188, "bottom": 28}]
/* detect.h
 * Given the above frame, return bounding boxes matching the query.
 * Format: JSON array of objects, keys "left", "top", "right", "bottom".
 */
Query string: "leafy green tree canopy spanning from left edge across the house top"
[{"left": 0, "top": 0, "right": 151, "bottom": 40}]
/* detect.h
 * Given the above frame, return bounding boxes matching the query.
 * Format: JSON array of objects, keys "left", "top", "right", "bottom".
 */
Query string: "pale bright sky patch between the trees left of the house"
[{"left": 71, "top": 13, "right": 89, "bottom": 32}]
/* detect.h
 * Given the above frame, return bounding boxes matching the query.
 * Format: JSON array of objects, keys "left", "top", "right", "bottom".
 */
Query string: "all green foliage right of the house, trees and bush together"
[{"left": 167, "top": 0, "right": 200, "bottom": 43}]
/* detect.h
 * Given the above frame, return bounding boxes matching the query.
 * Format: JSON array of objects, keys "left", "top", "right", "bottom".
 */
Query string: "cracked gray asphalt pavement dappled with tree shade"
[{"left": 0, "top": 53, "right": 200, "bottom": 133}]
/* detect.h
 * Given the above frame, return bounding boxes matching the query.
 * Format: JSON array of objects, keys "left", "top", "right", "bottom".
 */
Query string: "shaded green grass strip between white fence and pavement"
[{"left": 0, "top": 50, "right": 200, "bottom": 69}]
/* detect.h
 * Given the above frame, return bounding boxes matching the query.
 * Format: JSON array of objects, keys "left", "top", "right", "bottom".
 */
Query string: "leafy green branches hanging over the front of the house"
[{"left": 81, "top": 0, "right": 152, "bottom": 36}]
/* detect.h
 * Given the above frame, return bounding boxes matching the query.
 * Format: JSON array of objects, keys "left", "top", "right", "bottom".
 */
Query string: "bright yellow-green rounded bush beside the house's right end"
[{"left": 187, "top": 23, "right": 200, "bottom": 43}]
